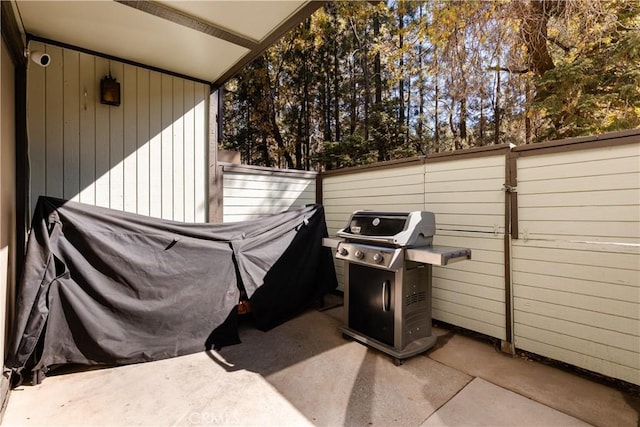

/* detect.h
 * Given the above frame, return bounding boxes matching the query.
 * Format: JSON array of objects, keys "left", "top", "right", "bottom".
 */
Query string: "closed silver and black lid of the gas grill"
[{"left": 337, "top": 211, "right": 436, "bottom": 246}]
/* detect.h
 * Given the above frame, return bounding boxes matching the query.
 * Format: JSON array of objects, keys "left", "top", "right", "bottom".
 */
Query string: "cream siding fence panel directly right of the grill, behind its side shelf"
[{"left": 423, "top": 154, "right": 507, "bottom": 339}]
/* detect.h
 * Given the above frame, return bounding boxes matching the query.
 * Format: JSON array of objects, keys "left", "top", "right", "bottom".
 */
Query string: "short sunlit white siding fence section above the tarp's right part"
[{"left": 222, "top": 165, "right": 317, "bottom": 222}]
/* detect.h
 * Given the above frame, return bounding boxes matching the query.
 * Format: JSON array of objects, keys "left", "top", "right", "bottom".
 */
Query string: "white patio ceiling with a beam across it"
[{"left": 15, "top": 0, "right": 322, "bottom": 85}]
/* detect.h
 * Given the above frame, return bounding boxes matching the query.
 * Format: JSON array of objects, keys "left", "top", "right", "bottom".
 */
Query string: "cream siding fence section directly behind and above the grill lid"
[{"left": 322, "top": 164, "right": 424, "bottom": 289}]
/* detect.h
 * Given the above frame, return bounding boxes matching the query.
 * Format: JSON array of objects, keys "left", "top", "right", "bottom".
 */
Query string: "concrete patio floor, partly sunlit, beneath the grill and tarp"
[{"left": 3, "top": 298, "right": 640, "bottom": 427}]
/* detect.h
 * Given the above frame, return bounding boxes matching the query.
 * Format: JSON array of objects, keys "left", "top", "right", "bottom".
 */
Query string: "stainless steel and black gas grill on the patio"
[{"left": 335, "top": 211, "right": 471, "bottom": 365}]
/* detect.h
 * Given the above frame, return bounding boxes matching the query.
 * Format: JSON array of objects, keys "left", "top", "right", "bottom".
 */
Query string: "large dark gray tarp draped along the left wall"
[{"left": 7, "top": 197, "right": 337, "bottom": 382}]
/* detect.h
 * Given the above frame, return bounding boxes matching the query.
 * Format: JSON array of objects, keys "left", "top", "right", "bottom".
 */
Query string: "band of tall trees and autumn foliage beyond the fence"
[{"left": 222, "top": 0, "right": 640, "bottom": 169}]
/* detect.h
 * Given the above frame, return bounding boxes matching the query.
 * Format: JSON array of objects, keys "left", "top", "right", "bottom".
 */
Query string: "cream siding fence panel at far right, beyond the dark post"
[{"left": 513, "top": 144, "right": 640, "bottom": 384}]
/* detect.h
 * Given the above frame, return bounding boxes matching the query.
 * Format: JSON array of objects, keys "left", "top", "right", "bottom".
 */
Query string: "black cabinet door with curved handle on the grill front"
[{"left": 349, "top": 263, "right": 395, "bottom": 346}]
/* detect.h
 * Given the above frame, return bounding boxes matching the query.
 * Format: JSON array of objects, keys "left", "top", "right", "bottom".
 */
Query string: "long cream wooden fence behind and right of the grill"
[{"left": 322, "top": 130, "right": 640, "bottom": 384}]
